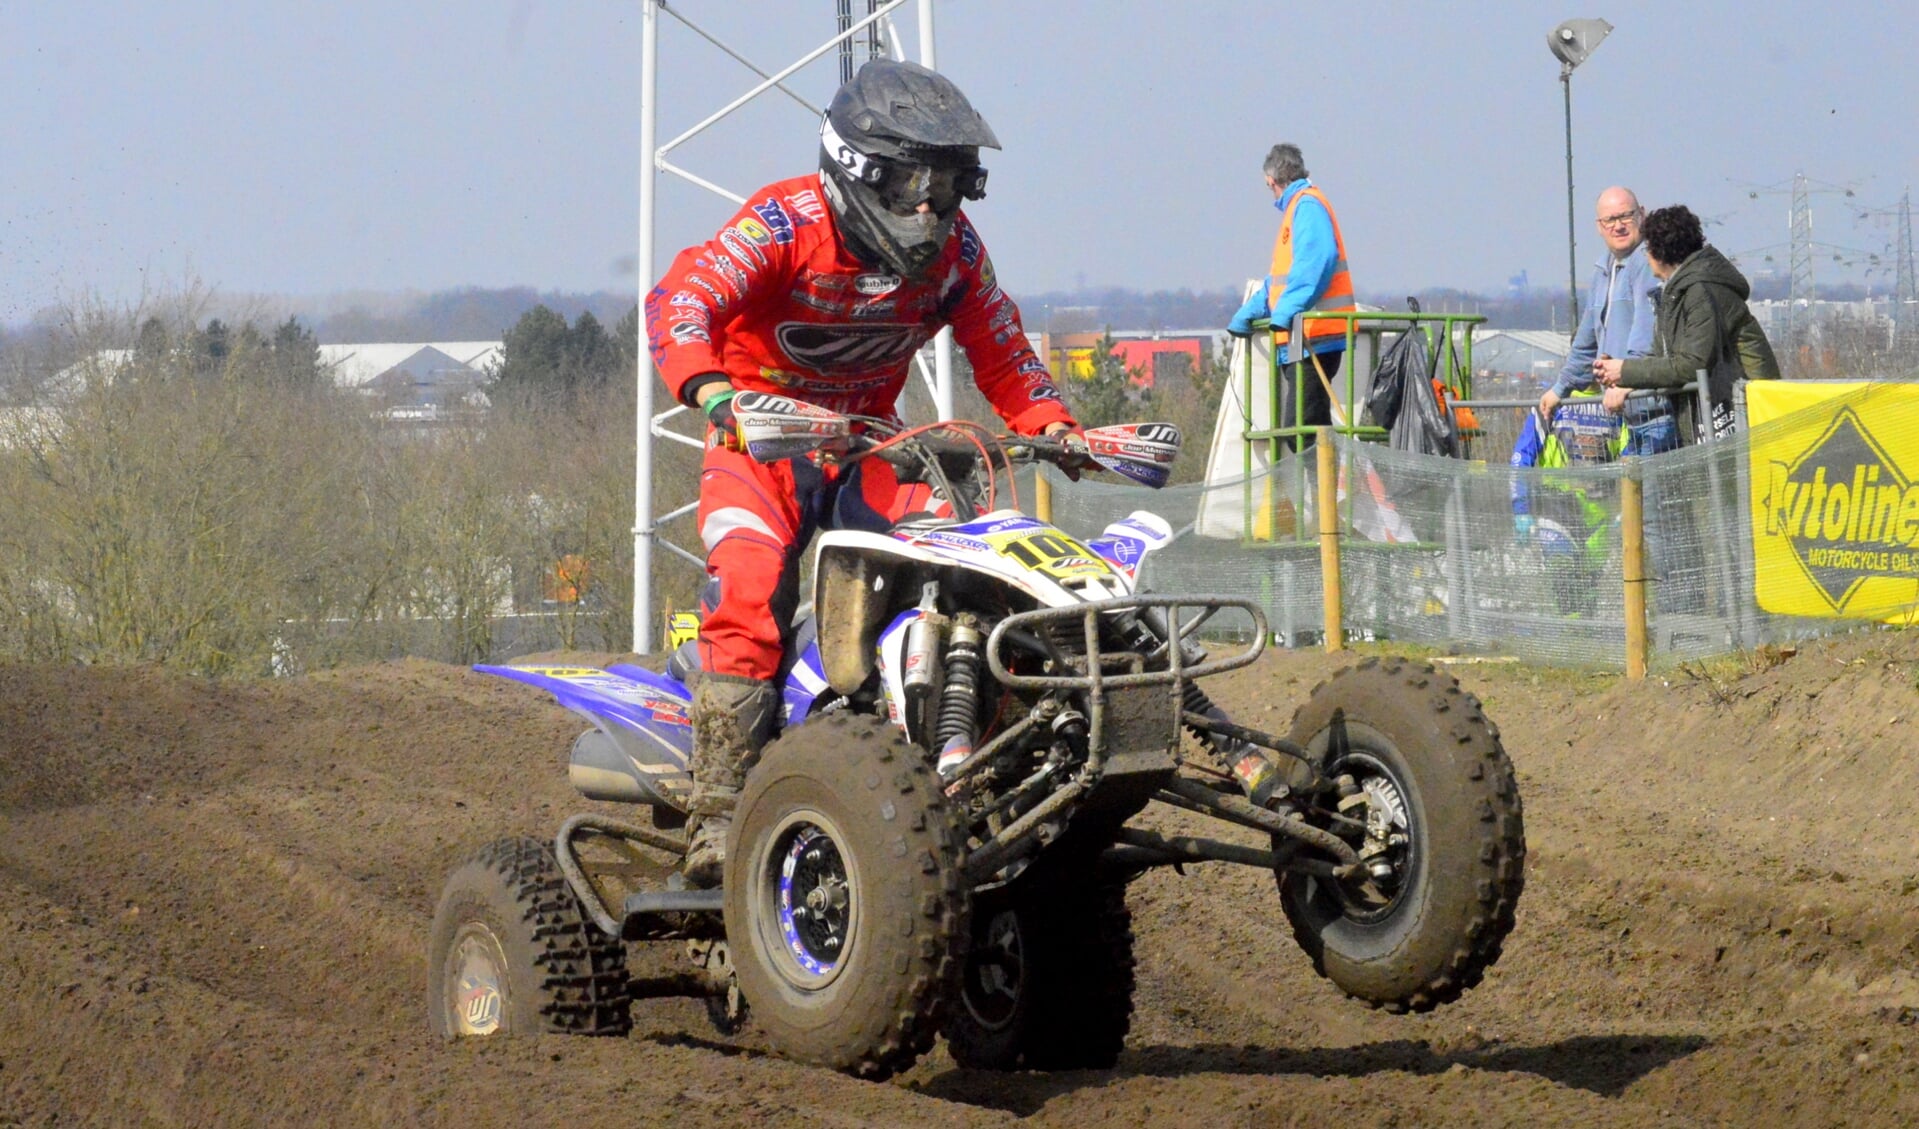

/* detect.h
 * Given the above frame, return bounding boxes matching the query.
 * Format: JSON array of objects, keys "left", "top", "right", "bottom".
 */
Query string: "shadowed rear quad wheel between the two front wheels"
[{"left": 946, "top": 876, "right": 1134, "bottom": 1069}]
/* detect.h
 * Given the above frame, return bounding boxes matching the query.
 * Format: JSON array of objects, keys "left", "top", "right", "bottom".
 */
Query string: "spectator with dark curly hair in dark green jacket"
[{"left": 1593, "top": 204, "right": 1779, "bottom": 438}]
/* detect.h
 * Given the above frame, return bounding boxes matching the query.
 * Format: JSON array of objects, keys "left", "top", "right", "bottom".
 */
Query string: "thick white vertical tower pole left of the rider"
[{"left": 633, "top": 0, "right": 660, "bottom": 655}]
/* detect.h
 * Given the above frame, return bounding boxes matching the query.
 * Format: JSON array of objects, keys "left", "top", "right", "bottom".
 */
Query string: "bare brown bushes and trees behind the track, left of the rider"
[{"left": 0, "top": 295, "right": 699, "bottom": 674}]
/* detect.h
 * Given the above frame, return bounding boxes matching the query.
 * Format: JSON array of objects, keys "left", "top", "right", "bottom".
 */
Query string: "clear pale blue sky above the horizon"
[{"left": 0, "top": 0, "right": 1919, "bottom": 323}]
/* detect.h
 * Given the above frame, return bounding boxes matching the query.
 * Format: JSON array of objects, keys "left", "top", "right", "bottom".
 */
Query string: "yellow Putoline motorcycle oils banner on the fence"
[{"left": 1746, "top": 380, "right": 1919, "bottom": 622}]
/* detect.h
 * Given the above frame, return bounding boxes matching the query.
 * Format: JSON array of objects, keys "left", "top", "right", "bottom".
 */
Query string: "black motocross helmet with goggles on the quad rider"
[{"left": 819, "top": 60, "right": 1000, "bottom": 276}]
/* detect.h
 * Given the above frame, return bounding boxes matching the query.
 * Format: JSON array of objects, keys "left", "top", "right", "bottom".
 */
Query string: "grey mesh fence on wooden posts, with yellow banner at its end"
[{"left": 1052, "top": 386, "right": 1919, "bottom": 668}]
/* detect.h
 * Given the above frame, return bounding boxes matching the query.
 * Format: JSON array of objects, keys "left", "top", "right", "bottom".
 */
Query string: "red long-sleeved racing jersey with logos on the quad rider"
[{"left": 647, "top": 173, "right": 1075, "bottom": 434}]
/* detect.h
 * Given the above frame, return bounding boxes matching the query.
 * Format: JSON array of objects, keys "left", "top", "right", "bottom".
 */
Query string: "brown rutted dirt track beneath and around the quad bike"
[{"left": 0, "top": 632, "right": 1919, "bottom": 1129}]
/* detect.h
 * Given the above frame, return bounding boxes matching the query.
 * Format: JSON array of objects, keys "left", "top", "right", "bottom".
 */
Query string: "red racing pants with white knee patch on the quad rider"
[{"left": 699, "top": 435, "right": 946, "bottom": 680}]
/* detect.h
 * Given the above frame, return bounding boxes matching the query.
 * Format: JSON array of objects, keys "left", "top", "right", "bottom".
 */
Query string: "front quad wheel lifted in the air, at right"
[{"left": 1276, "top": 659, "right": 1526, "bottom": 1012}]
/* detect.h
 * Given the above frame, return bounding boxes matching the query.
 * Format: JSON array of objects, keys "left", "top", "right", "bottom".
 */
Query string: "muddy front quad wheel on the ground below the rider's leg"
[{"left": 725, "top": 712, "right": 969, "bottom": 1079}]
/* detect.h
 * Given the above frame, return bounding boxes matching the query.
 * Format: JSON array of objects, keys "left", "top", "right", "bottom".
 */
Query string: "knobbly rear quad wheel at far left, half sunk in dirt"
[{"left": 426, "top": 839, "right": 631, "bottom": 1039}]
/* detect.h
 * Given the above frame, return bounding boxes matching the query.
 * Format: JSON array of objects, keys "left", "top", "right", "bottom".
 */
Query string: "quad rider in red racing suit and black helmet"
[{"left": 647, "top": 60, "right": 1077, "bottom": 885}]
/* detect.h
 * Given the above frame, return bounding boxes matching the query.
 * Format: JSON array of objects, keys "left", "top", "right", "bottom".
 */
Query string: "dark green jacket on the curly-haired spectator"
[{"left": 1620, "top": 246, "right": 1779, "bottom": 391}]
